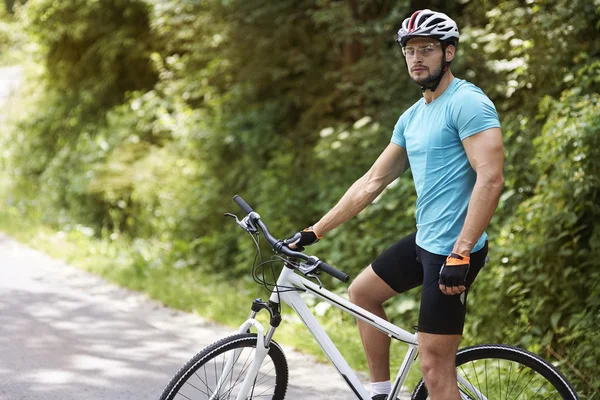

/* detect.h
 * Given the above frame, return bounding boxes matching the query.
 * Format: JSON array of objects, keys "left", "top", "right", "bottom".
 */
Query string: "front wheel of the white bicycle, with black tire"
[{"left": 160, "top": 333, "right": 288, "bottom": 400}]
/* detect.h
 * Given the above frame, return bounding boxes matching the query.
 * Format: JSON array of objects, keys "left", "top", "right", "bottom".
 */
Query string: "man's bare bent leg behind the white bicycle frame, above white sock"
[{"left": 348, "top": 265, "right": 398, "bottom": 382}]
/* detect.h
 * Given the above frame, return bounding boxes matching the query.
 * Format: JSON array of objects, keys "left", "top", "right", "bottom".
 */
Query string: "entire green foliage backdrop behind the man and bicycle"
[{"left": 0, "top": 0, "right": 600, "bottom": 396}]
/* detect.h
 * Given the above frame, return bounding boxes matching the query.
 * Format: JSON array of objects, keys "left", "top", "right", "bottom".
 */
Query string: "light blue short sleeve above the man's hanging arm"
[{"left": 452, "top": 90, "right": 500, "bottom": 140}]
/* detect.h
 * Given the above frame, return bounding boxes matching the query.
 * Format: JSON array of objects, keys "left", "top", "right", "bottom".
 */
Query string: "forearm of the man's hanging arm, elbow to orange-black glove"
[{"left": 452, "top": 176, "right": 504, "bottom": 255}]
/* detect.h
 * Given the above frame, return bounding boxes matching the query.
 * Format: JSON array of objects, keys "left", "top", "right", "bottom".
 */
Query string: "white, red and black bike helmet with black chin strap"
[{"left": 396, "top": 9, "right": 458, "bottom": 92}]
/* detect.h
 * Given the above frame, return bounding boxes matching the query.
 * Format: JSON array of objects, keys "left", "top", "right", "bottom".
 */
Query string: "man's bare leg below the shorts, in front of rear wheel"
[{"left": 419, "top": 332, "right": 461, "bottom": 400}]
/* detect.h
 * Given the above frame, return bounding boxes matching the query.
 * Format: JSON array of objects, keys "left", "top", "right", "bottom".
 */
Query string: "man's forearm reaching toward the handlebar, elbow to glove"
[{"left": 313, "top": 176, "right": 385, "bottom": 236}]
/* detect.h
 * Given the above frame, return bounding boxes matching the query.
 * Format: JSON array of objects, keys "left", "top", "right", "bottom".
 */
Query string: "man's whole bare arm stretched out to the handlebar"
[{"left": 313, "top": 143, "right": 409, "bottom": 236}]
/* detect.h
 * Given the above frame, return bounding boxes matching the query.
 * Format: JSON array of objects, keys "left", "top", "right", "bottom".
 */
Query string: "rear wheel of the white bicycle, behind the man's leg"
[{"left": 411, "top": 345, "right": 579, "bottom": 400}]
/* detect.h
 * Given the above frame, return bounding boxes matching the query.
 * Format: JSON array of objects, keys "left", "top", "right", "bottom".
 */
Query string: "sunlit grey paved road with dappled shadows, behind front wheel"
[{"left": 0, "top": 234, "right": 398, "bottom": 400}]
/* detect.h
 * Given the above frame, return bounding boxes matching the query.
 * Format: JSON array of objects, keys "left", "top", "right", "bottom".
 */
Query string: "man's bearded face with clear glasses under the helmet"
[{"left": 403, "top": 38, "right": 454, "bottom": 85}]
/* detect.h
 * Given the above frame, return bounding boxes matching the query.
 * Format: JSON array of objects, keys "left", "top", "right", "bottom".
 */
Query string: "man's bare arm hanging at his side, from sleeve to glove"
[{"left": 452, "top": 128, "right": 504, "bottom": 255}]
